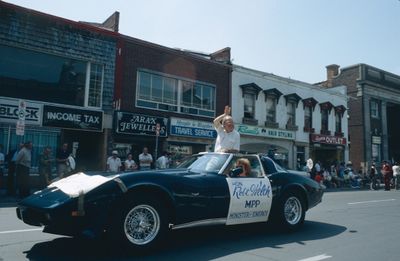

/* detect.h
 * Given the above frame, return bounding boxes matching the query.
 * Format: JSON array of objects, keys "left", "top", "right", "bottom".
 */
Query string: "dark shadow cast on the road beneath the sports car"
[{"left": 26, "top": 221, "right": 346, "bottom": 261}]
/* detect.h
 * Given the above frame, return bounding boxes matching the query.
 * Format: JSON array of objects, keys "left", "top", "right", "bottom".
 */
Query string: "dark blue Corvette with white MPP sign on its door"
[{"left": 16, "top": 153, "right": 324, "bottom": 251}]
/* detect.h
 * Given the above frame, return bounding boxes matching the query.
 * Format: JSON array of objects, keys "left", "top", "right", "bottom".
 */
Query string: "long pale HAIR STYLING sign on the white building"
[{"left": 237, "top": 124, "right": 295, "bottom": 140}]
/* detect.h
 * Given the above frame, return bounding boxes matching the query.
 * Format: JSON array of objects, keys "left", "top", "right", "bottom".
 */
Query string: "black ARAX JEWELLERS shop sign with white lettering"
[{"left": 115, "top": 111, "right": 168, "bottom": 137}]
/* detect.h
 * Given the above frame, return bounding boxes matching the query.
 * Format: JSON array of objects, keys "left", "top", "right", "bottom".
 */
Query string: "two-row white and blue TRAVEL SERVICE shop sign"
[{"left": 170, "top": 118, "right": 217, "bottom": 139}]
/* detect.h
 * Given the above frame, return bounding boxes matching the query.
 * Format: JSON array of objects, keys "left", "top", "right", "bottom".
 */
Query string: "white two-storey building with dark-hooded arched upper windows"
[{"left": 232, "top": 65, "right": 348, "bottom": 169}]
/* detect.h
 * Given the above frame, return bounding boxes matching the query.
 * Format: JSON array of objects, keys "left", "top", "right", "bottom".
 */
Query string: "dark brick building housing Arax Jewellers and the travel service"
[{"left": 109, "top": 35, "right": 231, "bottom": 167}]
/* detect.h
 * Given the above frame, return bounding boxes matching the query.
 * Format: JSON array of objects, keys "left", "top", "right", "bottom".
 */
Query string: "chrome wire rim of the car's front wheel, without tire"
[{"left": 124, "top": 205, "right": 160, "bottom": 245}]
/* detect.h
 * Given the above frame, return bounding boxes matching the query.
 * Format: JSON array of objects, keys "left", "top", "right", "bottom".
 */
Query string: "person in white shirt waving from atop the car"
[{"left": 214, "top": 106, "right": 240, "bottom": 152}]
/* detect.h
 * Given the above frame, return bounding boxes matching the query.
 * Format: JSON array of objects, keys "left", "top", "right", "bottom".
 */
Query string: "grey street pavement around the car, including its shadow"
[{"left": 0, "top": 189, "right": 400, "bottom": 261}]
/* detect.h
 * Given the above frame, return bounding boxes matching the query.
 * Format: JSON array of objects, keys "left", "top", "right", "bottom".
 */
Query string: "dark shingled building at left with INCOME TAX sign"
[{"left": 0, "top": 2, "right": 117, "bottom": 173}]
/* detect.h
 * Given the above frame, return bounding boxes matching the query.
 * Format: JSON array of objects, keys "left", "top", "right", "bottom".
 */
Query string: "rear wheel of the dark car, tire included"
[{"left": 279, "top": 191, "right": 306, "bottom": 231}]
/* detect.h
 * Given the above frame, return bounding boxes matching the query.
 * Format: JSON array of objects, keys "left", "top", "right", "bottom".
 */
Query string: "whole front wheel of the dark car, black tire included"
[{"left": 111, "top": 197, "right": 168, "bottom": 252}]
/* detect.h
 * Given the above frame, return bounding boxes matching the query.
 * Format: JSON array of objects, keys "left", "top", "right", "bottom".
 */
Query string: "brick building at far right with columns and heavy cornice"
[{"left": 319, "top": 64, "right": 400, "bottom": 173}]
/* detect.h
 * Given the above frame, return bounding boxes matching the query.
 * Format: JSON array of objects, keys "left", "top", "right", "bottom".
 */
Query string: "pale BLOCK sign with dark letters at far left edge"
[{"left": 0, "top": 99, "right": 42, "bottom": 125}]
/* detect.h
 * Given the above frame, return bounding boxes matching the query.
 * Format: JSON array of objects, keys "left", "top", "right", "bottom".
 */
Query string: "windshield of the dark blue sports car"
[{"left": 177, "top": 153, "right": 230, "bottom": 173}]
